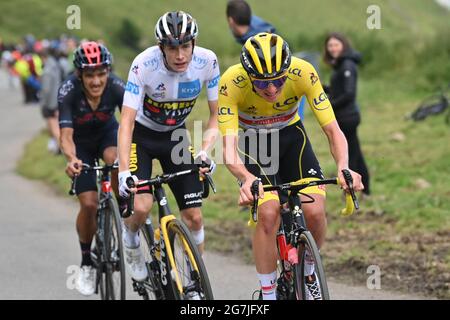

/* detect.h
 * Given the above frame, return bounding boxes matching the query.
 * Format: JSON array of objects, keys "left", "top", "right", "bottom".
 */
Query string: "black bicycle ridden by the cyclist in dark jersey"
[{"left": 69, "top": 161, "right": 126, "bottom": 300}]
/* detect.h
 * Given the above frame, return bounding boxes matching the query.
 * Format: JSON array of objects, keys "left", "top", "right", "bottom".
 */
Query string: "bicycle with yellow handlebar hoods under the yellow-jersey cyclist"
[{"left": 249, "top": 170, "right": 359, "bottom": 300}]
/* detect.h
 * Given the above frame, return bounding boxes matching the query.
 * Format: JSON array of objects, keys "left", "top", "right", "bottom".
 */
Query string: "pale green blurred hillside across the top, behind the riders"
[{"left": 0, "top": 0, "right": 450, "bottom": 76}]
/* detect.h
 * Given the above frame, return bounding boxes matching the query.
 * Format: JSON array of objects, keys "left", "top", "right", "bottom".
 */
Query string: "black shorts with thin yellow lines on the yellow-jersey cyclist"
[{"left": 239, "top": 121, "right": 324, "bottom": 202}]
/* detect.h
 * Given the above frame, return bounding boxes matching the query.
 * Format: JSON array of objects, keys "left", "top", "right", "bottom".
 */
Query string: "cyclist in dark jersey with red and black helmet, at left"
[{"left": 58, "top": 42, "right": 125, "bottom": 295}]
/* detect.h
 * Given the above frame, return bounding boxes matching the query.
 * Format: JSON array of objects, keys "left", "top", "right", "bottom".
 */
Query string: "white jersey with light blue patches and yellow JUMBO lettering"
[{"left": 123, "top": 46, "right": 220, "bottom": 131}]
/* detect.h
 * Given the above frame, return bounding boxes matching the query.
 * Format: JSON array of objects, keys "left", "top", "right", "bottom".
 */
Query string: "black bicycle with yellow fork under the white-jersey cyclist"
[{"left": 122, "top": 165, "right": 216, "bottom": 300}]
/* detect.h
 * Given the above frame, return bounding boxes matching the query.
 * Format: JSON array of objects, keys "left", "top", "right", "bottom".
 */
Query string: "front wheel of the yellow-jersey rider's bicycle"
[{"left": 294, "top": 231, "right": 330, "bottom": 300}]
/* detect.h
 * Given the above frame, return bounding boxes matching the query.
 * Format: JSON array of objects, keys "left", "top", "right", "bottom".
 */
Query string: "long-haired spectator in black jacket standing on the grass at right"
[{"left": 324, "top": 33, "right": 370, "bottom": 195}]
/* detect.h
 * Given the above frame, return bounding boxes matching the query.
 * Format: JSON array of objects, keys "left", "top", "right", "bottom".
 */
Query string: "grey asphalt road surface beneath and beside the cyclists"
[{"left": 0, "top": 70, "right": 428, "bottom": 300}]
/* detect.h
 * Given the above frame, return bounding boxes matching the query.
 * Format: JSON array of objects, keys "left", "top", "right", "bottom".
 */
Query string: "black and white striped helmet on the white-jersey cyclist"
[{"left": 155, "top": 11, "right": 198, "bottom": 46}]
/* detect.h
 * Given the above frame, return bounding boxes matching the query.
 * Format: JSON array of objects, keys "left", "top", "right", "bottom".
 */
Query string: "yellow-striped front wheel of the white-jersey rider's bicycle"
[{"left": 165, "top": 220, "right": 214, "bottom": 300}]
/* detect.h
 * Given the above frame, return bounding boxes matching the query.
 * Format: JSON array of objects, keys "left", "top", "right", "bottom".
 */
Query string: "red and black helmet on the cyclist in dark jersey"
[{"left": 73, "top": 41, "right": 112, "bottom": 70}]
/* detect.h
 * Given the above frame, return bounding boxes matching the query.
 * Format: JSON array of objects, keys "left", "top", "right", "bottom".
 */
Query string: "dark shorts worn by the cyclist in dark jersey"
[{"left": 75, "top": 126, "right": 117, "bottom": 195}]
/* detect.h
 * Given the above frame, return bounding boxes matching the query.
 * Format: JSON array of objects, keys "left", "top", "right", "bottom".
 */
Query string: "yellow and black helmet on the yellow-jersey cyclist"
[{"left": 241, "top": 32, "right": 291, "bottom": 79}]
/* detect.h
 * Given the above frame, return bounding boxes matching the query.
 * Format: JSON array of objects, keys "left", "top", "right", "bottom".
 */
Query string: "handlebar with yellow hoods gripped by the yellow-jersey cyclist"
[{"left": 249, "top": 169, "right": 359, "bottom": 224}]
